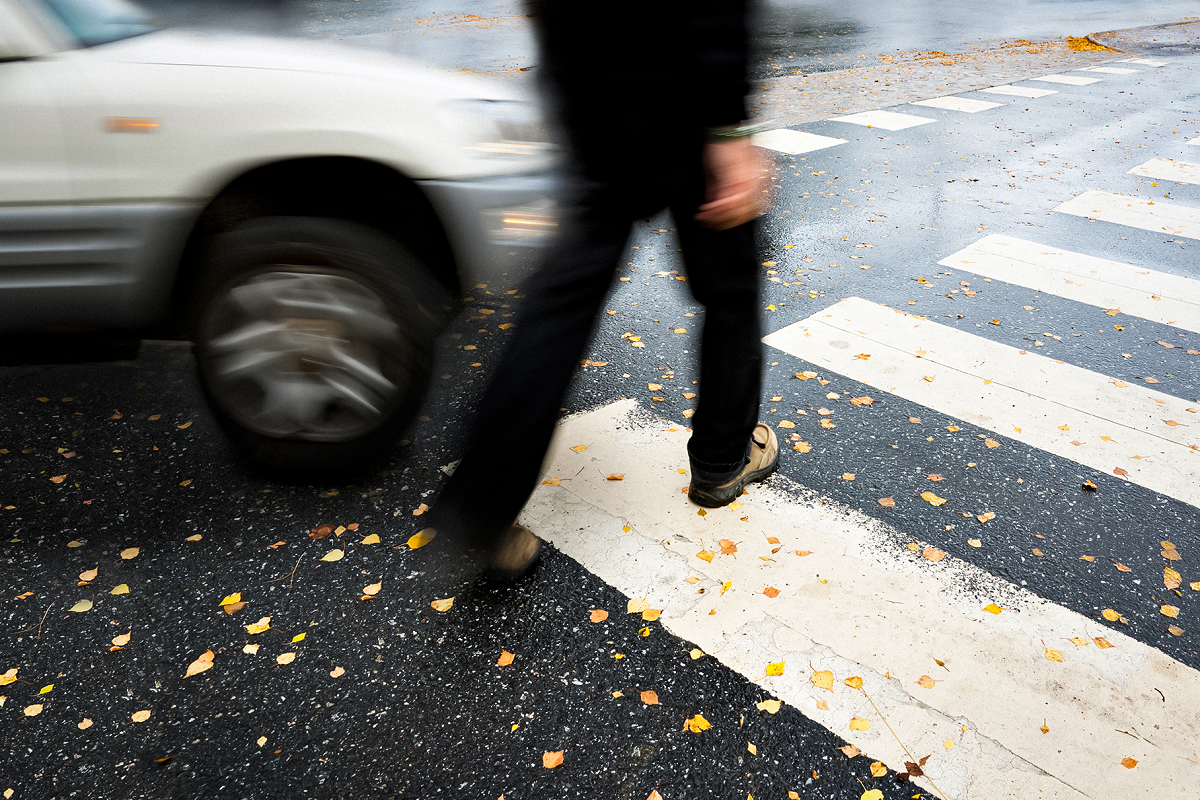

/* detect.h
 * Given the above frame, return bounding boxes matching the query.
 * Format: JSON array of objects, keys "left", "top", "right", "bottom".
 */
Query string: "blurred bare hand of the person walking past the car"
[{"left": 696, "top": 138, "right": 770, "bottom": 230}]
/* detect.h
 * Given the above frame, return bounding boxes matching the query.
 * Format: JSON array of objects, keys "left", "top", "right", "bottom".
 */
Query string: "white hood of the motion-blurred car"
[{"left": 91, "top": 29, "right": 520, "bottom": 100}]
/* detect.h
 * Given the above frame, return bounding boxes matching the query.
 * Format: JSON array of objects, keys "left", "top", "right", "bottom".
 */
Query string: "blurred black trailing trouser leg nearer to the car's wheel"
[{"left": 431, "top": 199, "right": 630, "bottom": 546}]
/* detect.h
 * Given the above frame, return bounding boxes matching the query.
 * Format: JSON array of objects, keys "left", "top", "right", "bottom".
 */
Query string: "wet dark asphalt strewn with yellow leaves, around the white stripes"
[{"left": 0, "top": 9, "right": 1200, "bottom": 800}]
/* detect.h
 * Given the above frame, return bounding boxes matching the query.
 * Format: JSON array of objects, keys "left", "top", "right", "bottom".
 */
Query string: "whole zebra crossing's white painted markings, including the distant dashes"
[{"left": 537, "top": 59, "right": 1200, "bottom": 800}]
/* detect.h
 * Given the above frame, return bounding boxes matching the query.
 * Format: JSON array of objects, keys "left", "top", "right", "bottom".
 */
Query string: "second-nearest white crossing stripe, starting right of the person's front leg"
[{"left": 763, "top": 297, "right": 1200, "bottom": 506}]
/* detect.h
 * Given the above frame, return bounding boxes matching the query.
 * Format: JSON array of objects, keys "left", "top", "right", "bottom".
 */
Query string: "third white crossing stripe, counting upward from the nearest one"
[{"left": 938, "top": 234, "right": 1200, "bottom": 333}]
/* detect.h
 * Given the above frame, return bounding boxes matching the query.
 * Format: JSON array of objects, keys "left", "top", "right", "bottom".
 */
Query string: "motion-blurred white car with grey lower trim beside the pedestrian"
[{"left": 0, "top": 0, "right": 556, "bottom": 475}]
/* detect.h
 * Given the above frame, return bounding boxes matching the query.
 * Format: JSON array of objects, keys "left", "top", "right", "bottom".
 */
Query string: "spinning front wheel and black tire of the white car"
[{"left": 193, "top": 217, "right": 445, "bottom": 480}]
